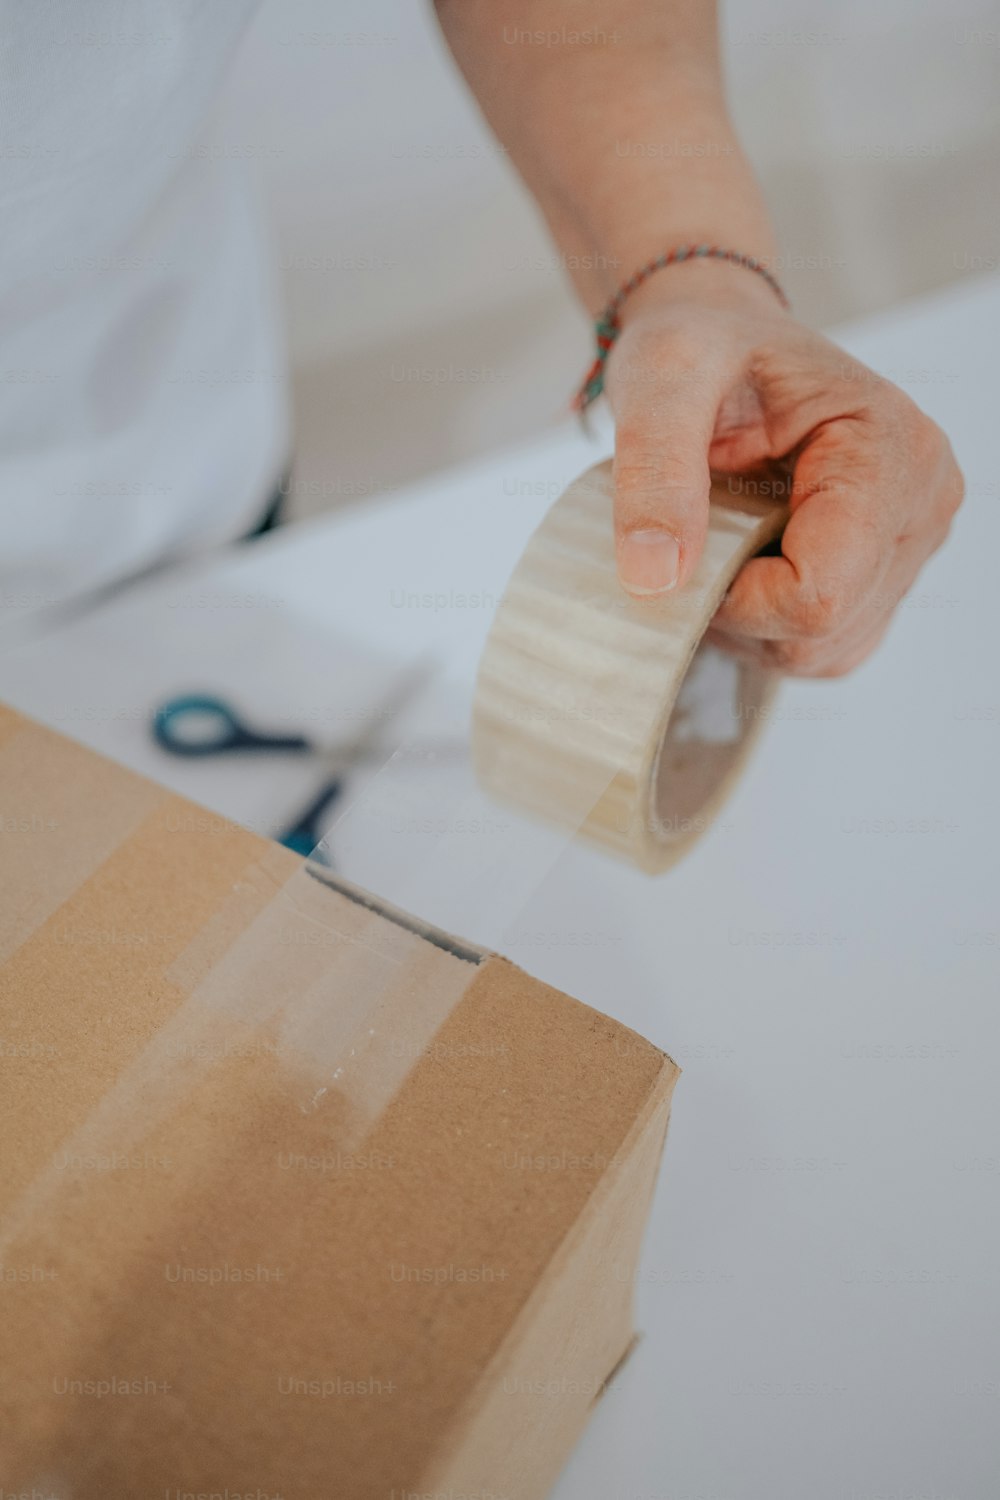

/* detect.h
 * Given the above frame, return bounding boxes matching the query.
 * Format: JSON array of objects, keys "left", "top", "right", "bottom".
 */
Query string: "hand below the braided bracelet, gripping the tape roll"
[{"left": 606, "top": 273, "right": 964, "bottom": 677}]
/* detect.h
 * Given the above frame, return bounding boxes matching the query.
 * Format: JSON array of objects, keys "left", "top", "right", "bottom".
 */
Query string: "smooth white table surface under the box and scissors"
[{"left": 0, "top": 279, "right": 1000, "bottom": 1500}]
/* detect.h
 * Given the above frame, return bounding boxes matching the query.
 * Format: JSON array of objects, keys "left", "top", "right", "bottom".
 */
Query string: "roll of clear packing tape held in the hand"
[{"left": 472, "top": 461, "right": 787, "bottom": 873}]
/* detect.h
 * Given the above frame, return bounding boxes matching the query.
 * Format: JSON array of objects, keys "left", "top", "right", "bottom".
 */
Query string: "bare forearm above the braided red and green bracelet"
[{"left": 438, "top": 0, "right": 774, "bottom": 312}]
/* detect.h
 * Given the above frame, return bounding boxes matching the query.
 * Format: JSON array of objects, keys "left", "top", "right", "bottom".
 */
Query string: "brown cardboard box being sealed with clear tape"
[{"left": 0, "top": 710, "right": 676, "bottom": 1500}]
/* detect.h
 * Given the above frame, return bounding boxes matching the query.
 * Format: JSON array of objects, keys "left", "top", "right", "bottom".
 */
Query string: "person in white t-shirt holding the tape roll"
[{"left": 0, "top": 0, "right": 963, "bottom": 677}]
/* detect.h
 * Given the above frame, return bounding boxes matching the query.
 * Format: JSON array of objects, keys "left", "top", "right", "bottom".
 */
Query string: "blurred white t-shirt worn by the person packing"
[{"left": 0, "top": 0, "right": 288, "bottom": 635}]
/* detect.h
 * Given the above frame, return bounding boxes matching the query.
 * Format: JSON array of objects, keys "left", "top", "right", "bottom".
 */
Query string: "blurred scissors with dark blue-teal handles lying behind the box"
[{"left": 151, "top": 662, "right": 433, "bottom": 857}]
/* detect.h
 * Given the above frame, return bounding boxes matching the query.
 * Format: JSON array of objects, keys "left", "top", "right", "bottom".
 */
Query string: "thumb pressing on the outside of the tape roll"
[{"left": 609, "top": 345, "right": 724, "bottom": 596}]
